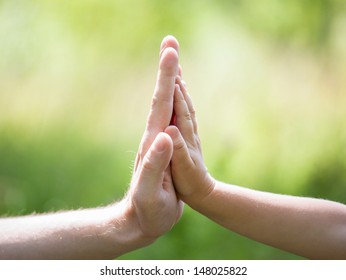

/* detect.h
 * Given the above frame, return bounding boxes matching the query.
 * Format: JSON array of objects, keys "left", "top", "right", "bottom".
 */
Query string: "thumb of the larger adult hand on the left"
[{"left": 139, "top": 132, "right": 173, "bottom": 190}]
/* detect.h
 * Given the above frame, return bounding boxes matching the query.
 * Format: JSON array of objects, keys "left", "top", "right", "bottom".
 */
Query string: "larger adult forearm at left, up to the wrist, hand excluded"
[{"left": 0, "top": 203, "right": 153, "bottom": 259}]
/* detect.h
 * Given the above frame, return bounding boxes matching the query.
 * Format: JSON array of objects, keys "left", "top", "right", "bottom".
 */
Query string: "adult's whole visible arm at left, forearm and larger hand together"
[{"left": 0, "top": 36, "right": 183, "bottom": 259}]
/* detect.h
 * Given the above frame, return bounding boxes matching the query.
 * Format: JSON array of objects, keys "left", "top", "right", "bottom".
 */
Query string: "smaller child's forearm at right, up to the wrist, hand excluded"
[{"left": 190, "top": 182, "right": 346, "bottom": 259}]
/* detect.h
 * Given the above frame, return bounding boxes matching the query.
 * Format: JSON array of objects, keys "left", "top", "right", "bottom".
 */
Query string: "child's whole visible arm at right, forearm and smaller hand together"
[{"left": 166, "top": 78, "right": 346, "bottom": 259}]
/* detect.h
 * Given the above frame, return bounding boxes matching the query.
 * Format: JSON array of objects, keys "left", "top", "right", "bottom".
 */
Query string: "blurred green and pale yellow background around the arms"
[{"left": 0, "top": 0, "right": 346, "bottom": 259}]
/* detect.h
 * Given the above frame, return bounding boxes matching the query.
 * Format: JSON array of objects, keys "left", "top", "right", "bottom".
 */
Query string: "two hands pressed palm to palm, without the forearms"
[{"left": 126, "top": 36, "right": 214, "bottom": 242}]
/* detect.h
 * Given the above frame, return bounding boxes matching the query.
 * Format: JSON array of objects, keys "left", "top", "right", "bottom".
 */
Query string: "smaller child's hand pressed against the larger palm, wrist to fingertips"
[{"left": 165, "top": 77, "right": 215, "bottom": 206}]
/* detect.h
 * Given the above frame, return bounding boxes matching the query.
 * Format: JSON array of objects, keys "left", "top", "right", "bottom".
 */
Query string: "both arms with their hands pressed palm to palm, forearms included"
[{"left": 0, "top": 36, "right": 346, "bottom": 259}]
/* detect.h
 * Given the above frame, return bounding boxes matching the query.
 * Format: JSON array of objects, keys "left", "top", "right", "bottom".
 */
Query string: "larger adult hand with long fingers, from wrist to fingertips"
[{"left": 128, "top": 36, "right": 183, "bottom": 238}]
